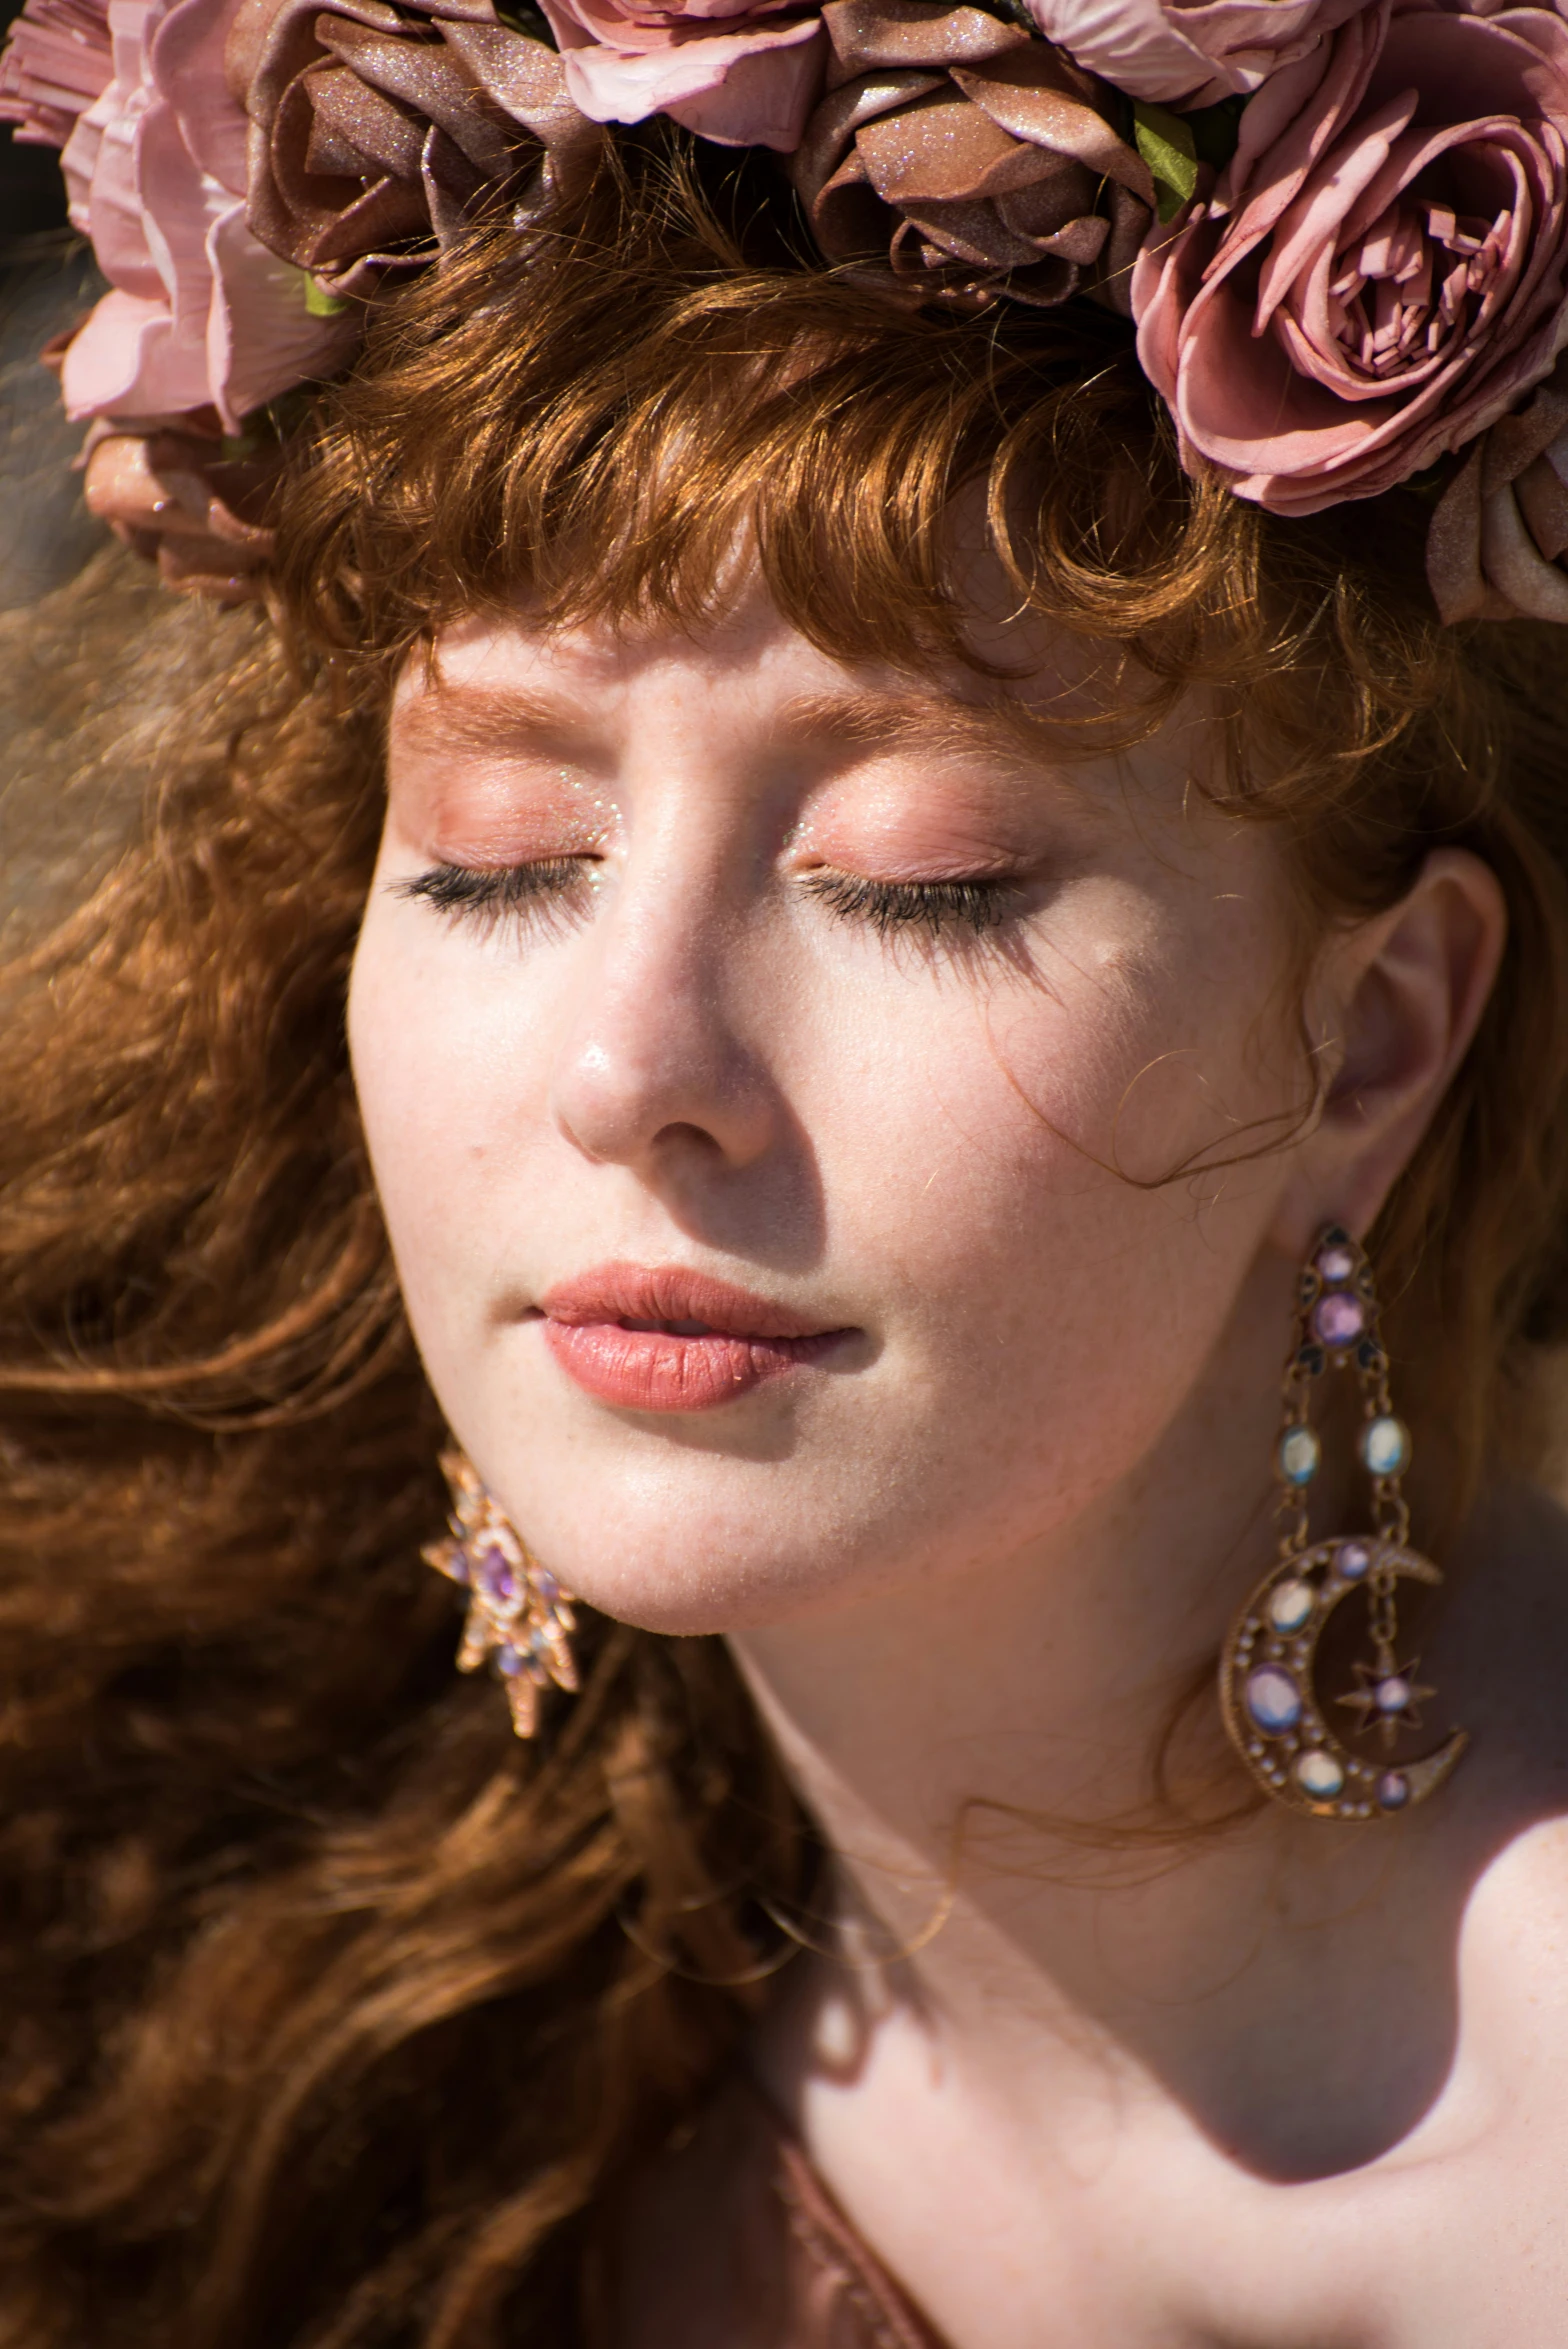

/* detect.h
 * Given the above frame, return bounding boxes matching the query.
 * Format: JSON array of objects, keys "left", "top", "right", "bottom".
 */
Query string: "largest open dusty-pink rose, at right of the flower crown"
[{"left": 1134, "top": 0, "right": 1568, "bottom": 514}]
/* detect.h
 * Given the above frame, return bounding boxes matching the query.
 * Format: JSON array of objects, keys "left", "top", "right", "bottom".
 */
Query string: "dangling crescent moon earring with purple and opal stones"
[{"left": 1221, "top": 1224, "right": 1467, "bottom": 1818}]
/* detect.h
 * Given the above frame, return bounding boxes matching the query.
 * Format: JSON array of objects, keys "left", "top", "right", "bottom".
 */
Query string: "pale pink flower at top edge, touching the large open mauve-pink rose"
[{"left": 1026, "top": 0, "right": 1366, "bottom": 108}]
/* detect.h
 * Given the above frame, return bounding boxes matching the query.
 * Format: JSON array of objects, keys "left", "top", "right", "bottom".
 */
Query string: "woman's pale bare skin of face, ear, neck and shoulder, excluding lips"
[{"left": 350, "top": 573, "right": 1568, "bottom": 2349}]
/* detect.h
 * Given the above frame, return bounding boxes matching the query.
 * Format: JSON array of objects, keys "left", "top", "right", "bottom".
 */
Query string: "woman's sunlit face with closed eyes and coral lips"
[{"left": 350, "top": 577, "right": 1305, "bottom": 1630}]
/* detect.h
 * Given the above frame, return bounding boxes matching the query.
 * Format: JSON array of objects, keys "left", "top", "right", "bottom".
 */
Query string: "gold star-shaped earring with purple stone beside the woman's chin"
[{"left": 420, "top": 1452, "right": 577, "bottom": 1738}]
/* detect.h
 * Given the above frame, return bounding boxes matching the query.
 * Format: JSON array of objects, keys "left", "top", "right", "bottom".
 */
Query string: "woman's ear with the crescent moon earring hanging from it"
[{"left": 1275, "top": 848, "right": 1507, "bottom": 1257}]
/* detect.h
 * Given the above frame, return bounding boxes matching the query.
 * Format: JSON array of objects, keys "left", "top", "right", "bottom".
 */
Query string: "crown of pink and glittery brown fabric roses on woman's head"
[{"left": 0, "top": 0, "right": 1568, "bottom": 620}]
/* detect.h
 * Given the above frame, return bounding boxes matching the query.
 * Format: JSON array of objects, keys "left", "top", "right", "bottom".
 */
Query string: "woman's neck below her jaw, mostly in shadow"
[{"left": 732, "top": 1259, "right": 1464, "bottom": 2170}]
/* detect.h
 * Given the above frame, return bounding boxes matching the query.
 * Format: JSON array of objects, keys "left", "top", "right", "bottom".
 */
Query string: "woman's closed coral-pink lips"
[{"left": 540, "top": 1264, "right": 854, "bottom": 1412}]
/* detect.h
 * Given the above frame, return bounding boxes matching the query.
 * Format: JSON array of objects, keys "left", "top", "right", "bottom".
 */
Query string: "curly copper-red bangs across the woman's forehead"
[{"left": 282, "top": 142, "right": 1256, "bottom": 695}]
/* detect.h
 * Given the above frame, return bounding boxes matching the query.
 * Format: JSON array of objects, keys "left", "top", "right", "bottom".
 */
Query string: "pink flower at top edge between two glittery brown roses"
[{"left": 540, "top": 0, "right": 824, "bottom": 155}]
